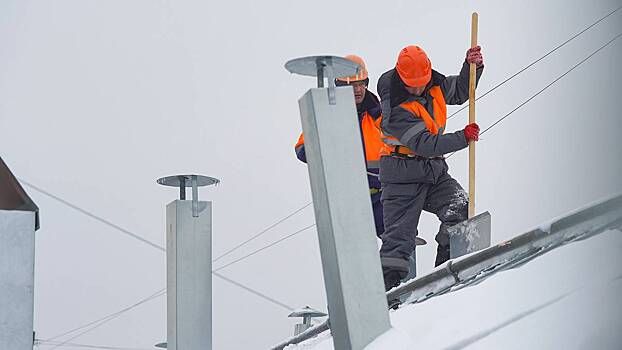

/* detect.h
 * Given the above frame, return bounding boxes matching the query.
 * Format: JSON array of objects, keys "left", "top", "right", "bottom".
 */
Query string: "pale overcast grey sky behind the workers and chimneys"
[{"left": 0, "top": 0, "right": 622, "bottom": 349}]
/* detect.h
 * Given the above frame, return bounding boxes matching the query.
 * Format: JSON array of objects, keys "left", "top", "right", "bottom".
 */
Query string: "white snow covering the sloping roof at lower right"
[{"left": 286, "top": 228, "right": 622, "bottom": 350}]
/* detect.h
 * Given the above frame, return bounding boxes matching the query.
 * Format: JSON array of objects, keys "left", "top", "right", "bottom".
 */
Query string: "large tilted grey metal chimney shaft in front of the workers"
[{"left": 299, "top": 85, "right": 390, "bottom": 350}]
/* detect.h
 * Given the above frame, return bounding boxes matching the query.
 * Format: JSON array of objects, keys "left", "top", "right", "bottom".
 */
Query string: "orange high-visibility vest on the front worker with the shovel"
[{"left": 380, "top": 86, "right": 447, "bottom": 156}]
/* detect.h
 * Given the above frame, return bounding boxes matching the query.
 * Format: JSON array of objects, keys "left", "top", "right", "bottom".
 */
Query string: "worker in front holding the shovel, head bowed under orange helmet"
[{"left": 378, "top": 46, "right": 484, "bottom": 290}]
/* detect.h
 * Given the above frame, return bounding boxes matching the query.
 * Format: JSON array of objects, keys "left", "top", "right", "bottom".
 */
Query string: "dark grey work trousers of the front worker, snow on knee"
[{"left": 380, "top": 165, "right": 468, "bottom": 273}]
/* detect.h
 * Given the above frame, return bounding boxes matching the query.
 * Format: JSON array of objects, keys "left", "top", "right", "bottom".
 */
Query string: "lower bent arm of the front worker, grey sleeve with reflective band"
[{"left": 382, "top": 106, "right": 468, "bottom": 157}]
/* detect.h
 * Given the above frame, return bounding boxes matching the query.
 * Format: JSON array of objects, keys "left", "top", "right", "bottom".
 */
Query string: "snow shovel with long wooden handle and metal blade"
[{"left": 448, "top": 12, "right": 491, "bottom": 259}]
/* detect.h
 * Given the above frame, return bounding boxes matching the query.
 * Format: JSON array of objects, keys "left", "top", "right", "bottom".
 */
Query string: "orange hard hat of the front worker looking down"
[{"left": 395, "top": 45, "right": 432, "bottom": 87}]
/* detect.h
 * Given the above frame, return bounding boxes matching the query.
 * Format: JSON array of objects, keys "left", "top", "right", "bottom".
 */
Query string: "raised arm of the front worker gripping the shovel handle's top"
[{"left": 441, "top": 46, "right": 484, "bottom": 105}]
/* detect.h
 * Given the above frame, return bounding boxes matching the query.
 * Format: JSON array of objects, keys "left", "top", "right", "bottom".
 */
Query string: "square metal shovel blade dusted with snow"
[{"left": 448, "top": 211, "right": 491, "bottom": 259}]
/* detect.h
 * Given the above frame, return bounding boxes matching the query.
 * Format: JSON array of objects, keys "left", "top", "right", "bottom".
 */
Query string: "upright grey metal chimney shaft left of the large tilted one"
[{"left": 166, "top": 200, "right": 212, "bottom": 350}]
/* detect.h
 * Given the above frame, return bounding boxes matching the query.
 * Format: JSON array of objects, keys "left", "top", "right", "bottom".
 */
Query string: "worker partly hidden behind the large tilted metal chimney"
[{"left": 295, "top": 55, "right": 384, "bottom": 236}]
